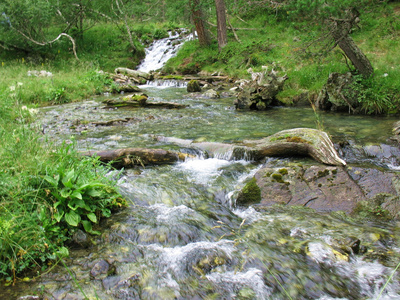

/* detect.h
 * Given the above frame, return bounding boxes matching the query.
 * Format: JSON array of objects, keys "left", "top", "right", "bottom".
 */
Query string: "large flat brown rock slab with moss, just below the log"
[{"left": 237, "top": 161, "right": 400, "bottom": 216}]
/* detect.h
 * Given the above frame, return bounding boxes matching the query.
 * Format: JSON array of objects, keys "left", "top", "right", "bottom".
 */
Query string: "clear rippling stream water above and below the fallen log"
[{"left": 12, "top": 86, "right": 400, "bottom": 300}]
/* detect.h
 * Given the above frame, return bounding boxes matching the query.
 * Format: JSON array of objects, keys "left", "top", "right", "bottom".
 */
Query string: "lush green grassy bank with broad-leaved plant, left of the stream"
[{"left": 0, "top": 62, "right": 126, "bottom": 283}]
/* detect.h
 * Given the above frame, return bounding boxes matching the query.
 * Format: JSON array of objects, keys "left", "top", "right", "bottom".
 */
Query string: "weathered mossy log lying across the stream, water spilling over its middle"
[{"left": 85, "top": 128, "right": 346, "bottom": 167}]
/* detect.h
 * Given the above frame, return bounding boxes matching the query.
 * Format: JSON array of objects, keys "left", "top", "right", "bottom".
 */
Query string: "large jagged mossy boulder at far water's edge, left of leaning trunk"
[{"left": 234, "top": 67, "right": 288, "bottom": 110}]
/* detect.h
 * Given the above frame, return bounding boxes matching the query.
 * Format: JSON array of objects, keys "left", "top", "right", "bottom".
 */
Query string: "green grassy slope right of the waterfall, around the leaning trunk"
[{"left": 164, "top": 3, "right": 400, "bottom": 113}]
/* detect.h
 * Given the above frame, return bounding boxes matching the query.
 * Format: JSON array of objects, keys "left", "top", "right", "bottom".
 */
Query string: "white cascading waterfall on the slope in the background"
[{"left": 137, "top": 30, "right": 193, "bottom": 72}]
